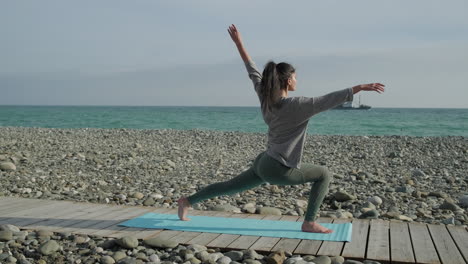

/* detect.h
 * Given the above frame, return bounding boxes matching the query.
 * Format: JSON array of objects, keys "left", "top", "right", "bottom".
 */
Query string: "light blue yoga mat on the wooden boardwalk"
[{"left": 119, "top": 213, "right": 352, "bottom": 241}]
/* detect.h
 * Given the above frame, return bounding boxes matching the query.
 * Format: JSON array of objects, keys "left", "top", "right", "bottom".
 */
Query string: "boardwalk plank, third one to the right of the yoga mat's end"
[{"left": 390, "top": 221, "right": 415, "bottom": 263}]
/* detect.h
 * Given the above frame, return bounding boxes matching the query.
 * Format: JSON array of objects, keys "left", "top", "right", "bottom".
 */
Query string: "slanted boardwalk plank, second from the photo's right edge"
[{"left": 428, "top": 225, "right": 464, "bottom": 264}]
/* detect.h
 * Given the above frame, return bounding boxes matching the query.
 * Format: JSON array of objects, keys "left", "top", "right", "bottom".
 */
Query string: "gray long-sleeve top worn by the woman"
[{"left": 245, "top": 61, "right": 353, "bottom": 169}]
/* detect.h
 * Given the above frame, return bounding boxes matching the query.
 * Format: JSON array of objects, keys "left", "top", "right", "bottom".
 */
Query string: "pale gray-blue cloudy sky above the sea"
[{"left": 0, "top": 0, "right": 468, "bottom": 108}]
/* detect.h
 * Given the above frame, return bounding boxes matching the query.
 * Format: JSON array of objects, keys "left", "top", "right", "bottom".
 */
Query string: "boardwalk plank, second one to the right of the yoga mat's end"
[{"left": 366, "top": 219, "right": 390, "bottom": 262}]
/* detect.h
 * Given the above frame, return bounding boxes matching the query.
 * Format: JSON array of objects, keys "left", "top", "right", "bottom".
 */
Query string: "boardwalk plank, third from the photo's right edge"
[{"left": 409, "top": 223, "right": 441, "bottom": 263}]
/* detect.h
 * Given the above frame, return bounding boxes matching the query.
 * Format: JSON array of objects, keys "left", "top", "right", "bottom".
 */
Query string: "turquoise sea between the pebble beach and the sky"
[{"left": 0, "top": 105, "right": 468, "bottom": 137}]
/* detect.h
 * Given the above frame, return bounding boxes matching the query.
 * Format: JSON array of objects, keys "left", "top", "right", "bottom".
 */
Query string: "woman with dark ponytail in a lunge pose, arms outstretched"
[{"left": 178, "top": 25, "right": 384, "bottom": 233}]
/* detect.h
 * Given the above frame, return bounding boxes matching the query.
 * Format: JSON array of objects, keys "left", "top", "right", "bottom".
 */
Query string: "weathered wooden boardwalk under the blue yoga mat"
[{"left": 0, "top": 197, "right": 468, "bottom": 264}]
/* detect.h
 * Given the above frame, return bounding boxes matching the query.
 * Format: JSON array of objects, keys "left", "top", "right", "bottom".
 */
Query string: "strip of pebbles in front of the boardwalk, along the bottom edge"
[{"left": 0, "top": 225, "right": 372, "bottom": 264}]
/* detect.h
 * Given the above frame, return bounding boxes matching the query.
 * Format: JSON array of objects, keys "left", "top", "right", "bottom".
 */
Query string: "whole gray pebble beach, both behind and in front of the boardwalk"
[{"left": 0, "top": 127, "right": 468, "bottom": 264}]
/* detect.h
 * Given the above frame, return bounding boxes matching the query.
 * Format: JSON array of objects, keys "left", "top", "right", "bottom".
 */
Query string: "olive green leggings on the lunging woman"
[{"left": 187, "top": 152, "right": 331, "bottom": 221}]
